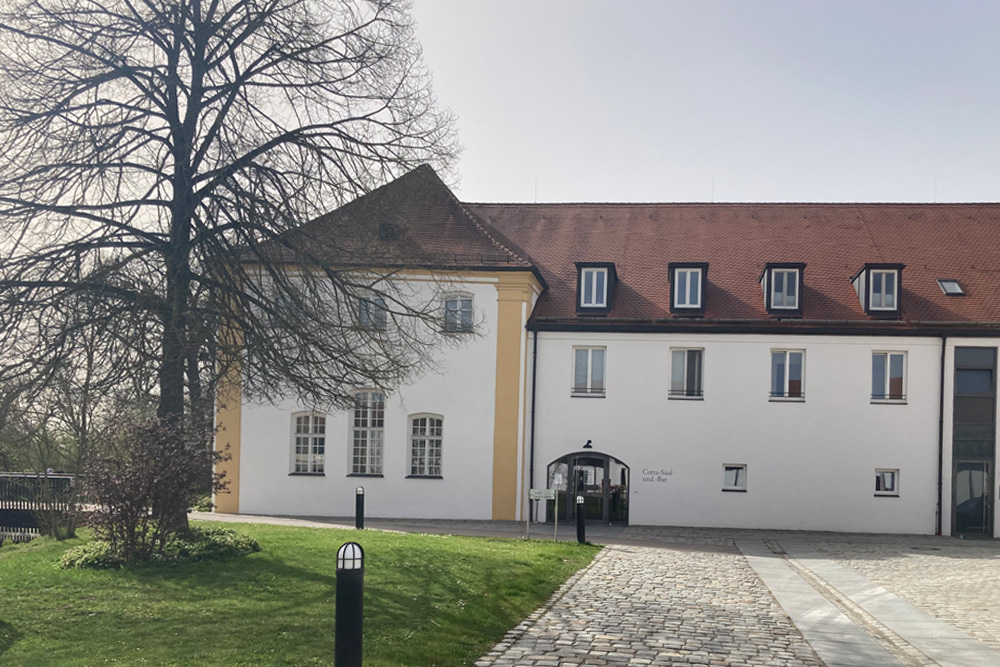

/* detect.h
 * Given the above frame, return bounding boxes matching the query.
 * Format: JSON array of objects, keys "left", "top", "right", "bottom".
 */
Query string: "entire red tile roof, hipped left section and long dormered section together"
[{"left": 300, "top": 166, "right": 1000, "bottom": 335}]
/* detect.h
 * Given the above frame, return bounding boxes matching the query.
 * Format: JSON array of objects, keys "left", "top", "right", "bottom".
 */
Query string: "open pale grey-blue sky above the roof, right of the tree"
[{"left": 414, "top": 0, "right": 1000, "bottom": 202}]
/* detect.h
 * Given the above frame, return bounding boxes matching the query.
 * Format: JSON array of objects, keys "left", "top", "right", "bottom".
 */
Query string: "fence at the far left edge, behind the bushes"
[{"left": 0, "top": 472, "right": 74, "bottom": 545}]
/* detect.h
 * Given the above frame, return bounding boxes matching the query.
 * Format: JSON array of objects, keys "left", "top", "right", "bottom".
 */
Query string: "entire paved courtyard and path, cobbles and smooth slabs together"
[{"left": 195, "top": 514, "right": 1000, "bottom": 667}]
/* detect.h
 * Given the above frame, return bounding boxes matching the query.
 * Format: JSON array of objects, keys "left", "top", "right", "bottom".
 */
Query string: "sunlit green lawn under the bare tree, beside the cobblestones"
[{"left": 0, "top": 524, "right": 596, "bottom": 667}]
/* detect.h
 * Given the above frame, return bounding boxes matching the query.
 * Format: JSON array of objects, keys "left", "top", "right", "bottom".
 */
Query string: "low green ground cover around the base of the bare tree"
[{"left": 60, "top": 528, "right": 260, "bottom": 570}]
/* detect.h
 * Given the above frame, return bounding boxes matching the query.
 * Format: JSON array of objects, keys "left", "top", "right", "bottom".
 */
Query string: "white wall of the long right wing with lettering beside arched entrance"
[{"left": 534, "top": 332, "right": 948, "bottom": 533}]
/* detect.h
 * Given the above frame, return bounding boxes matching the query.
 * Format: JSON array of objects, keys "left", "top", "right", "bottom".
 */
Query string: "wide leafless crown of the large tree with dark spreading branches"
[{"left": 0, "top": 0, "right": 456, "bottom": 528}]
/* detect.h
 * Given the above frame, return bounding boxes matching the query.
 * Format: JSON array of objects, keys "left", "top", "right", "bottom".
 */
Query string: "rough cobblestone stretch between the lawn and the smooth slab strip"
[{"left": 476, "top": 546, "right": 822, "bottom": 667}]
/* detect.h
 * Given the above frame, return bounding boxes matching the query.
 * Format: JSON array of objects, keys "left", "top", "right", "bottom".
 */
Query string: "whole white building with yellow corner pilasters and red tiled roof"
[{"left": 217, "top": 167, "right": 1000, "bottom": 536}]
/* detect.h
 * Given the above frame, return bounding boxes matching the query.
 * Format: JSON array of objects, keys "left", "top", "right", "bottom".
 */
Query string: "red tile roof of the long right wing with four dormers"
[{"left": 466, "top": 204, "right": 1000, "bottom": 326}]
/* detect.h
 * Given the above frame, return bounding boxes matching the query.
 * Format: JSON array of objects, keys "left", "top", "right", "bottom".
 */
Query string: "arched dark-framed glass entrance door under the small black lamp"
[{"left": 546, "top": 451, "right": 629, "bottom": 525}]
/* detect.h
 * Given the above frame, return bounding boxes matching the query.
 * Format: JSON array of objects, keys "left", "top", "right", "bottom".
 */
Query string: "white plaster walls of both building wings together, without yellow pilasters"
[{"left": 232, "top": 320, "right": 1000, "bottom": 535}]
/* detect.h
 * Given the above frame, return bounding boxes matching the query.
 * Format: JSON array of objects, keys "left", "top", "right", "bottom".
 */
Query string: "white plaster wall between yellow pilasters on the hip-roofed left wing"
[{"left": 233, "top": 277, "right": 498, "bottom": 519}]
